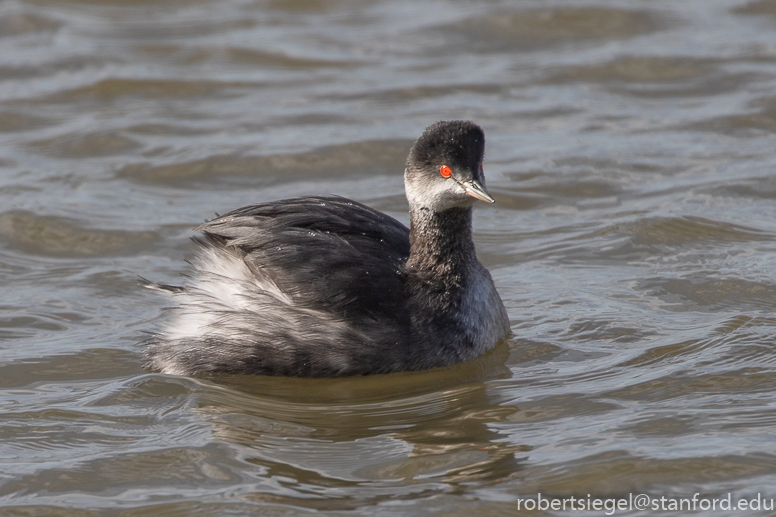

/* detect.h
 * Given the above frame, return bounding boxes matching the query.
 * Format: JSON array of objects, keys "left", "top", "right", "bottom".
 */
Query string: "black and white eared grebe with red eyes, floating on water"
[{"left": 146, "top": 121, "right": 509, "bottom": 377}]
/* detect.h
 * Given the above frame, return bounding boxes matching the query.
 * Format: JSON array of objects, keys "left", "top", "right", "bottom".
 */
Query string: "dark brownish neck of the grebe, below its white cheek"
[{"left": 406, "top": 207, "right": 477, "bottom": 285}]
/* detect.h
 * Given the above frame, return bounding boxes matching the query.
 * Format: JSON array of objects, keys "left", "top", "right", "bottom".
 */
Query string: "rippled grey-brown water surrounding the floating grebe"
[{"left": 0, "top": 0, "right": 776, "bottom": 516}]
